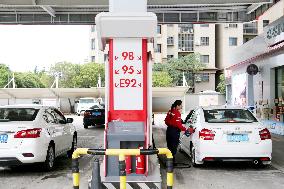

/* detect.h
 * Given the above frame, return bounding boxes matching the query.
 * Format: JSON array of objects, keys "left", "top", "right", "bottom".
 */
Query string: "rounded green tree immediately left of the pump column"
[{"left": 74, "top": 62, "right": 105, "bottom": 88}]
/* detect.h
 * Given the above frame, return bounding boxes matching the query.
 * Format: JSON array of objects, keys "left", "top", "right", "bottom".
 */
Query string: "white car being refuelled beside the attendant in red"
[{"left": 180, "top": 106, "right": 272, "bottom": 166}]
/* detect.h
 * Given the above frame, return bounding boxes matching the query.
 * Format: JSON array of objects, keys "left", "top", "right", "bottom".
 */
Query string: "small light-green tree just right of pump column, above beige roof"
[{"left": 152, "top": 71, "right": 173, "bottom": 87}]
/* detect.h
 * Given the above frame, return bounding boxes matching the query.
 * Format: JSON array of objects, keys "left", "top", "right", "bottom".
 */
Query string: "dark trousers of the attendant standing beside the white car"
[{"left": 166, "top": 126, "right": 180, "bottom": 161}]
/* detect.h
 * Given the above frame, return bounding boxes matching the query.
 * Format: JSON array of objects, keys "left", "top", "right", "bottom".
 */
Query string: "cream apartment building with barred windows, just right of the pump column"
[{"left": 154, "top": 24, "right": 217, "bottom": 92}]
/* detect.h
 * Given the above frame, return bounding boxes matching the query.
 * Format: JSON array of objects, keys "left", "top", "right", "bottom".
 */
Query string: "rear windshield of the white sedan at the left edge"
[{"left": 0, "top": 108, "right": 39, "bottom": 121}]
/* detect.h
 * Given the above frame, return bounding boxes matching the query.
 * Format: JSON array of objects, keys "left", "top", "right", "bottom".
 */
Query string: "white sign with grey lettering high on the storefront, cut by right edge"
[{"left": 265, "top": 16, "right": 284, "bottom": 46}]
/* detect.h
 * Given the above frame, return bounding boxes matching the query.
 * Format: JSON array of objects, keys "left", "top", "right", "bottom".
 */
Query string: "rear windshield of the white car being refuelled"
[{"left": 204, "top": 109, "right": 257, "bottom": 123}]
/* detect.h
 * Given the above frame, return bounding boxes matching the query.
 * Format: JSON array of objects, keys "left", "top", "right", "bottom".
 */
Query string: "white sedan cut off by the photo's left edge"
[{"left": 0, "top": 104, "right": 77, "bottom": 170}]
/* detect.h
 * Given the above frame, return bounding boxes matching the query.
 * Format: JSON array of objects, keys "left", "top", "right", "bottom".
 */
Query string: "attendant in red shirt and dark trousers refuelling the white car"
[{"left": 165, "top": 100, "right": 186, "bottom": 163}]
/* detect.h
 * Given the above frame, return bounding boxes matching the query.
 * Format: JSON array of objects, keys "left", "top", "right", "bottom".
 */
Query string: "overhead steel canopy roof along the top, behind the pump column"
[{"left": 0, "top": 0, "right": 271, "bottom": 24}]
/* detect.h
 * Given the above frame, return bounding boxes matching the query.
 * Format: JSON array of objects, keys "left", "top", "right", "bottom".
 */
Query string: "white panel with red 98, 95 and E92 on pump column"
[{"left": 110, "top": 39, "right": 144, "bottom": 110}]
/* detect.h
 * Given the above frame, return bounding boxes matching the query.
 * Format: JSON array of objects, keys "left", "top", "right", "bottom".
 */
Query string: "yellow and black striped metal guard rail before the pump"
[{"left": 72, "top": 148, "right": 174, "bottom": 189}]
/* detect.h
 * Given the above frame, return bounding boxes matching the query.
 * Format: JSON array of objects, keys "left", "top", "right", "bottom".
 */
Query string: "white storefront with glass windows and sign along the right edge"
[{"left": 225, "top": 16, "right": 284, "bottom": 135}]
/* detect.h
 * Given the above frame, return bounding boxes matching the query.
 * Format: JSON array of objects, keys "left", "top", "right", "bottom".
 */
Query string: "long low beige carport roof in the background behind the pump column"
[{"left": 0, "top": 87, "right": 188, "bottom": 99}]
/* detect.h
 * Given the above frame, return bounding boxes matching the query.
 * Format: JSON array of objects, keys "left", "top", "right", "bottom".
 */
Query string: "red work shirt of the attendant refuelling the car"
[{"left": 165, "top": 108, "right": 186, "bottom": 131}]
